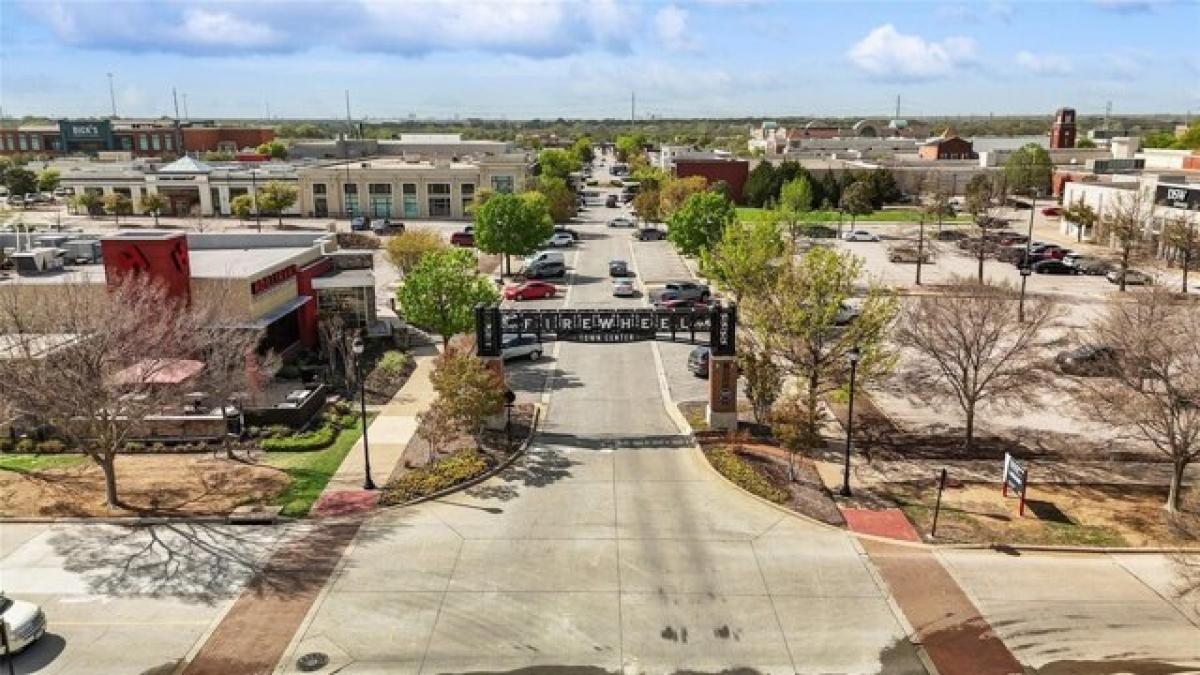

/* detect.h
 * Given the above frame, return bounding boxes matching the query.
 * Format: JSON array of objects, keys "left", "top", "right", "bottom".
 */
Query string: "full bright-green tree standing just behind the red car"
[{"left": 475, "top": 189, "right": 554, "bottom": 273}]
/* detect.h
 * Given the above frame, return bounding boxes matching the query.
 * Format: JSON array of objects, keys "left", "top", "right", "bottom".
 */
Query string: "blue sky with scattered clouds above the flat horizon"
[{"left": 0, "top": 0, "right": 1200, "bottom": 119}]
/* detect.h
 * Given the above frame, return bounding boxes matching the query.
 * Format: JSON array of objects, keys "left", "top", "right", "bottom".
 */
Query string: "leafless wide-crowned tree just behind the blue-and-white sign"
[{"left": 895, "top": 279, "right": 1056, "bottom": 450}]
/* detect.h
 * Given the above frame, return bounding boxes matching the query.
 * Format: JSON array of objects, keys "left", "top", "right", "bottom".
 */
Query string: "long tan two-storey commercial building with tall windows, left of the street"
[{"left": 298, "top": 154, "right": 528, "bottom": 219}]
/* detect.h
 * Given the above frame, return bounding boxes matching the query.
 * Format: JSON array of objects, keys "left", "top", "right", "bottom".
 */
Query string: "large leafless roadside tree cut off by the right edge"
[{"left": 1075, "top": 288, "right": 1200, "bottom": 513}]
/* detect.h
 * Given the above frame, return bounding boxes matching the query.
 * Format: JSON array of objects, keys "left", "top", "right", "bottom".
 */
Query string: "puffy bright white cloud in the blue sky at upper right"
[{"left": 847, "top": 24, "right": 976, "bottom": 79}]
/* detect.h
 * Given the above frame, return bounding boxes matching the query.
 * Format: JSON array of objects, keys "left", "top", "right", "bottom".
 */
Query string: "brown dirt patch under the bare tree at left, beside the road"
[{"left": 0, "top": 454, "right": 290, "bottom": 518}]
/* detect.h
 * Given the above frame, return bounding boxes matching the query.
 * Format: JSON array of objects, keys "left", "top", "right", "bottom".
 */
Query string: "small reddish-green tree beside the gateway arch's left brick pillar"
[{"left": 430, "top": 348, "right": 504, "bottom": 446}]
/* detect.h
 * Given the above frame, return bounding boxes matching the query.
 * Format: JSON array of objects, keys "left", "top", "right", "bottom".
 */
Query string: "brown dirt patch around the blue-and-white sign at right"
[{"left": 869, "top": 480, "right": 1200, "bottom": 546}]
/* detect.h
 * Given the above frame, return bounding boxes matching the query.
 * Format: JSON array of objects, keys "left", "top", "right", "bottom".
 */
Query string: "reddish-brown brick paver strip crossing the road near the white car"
[{"left": 184, "top": 519, "right": 362, "bottom": 675}]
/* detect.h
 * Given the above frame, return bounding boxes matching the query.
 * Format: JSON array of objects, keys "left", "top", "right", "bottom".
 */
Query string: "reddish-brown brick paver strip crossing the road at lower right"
[{"left": 862, "top": 539, "right": 1025, "bottom": 675}]
